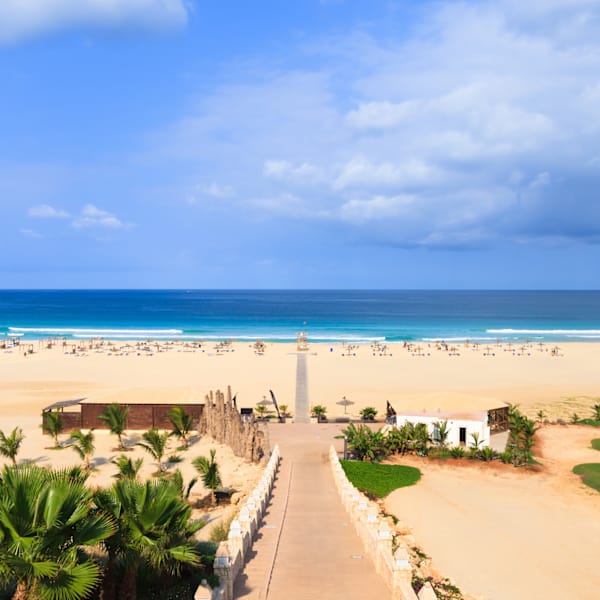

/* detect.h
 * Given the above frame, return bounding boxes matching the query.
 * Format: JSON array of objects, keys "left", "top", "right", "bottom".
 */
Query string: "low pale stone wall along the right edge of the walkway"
[{"left": 329, "top": 446, "right": 436, "bottom": 600}]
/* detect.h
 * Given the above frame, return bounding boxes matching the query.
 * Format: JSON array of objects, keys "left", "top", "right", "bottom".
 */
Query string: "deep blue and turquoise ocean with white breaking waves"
[{"left": 0, "top": 290, "right": 600, "bottom": 343}]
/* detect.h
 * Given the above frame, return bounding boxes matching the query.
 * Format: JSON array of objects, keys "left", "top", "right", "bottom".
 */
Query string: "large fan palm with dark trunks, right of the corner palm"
[{"left": 95, "top": 479, "right": 204, "bottom": 600}]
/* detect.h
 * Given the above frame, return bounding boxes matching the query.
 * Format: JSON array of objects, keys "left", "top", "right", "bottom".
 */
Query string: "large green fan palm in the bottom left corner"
[{"left": 0, "top": 466, "right": 113, "bottom": 600}]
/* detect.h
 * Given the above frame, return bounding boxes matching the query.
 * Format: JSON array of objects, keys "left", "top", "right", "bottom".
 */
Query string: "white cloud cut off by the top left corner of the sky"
[{"left": 0, "top": 0, "right": 187, "bottom": 43}]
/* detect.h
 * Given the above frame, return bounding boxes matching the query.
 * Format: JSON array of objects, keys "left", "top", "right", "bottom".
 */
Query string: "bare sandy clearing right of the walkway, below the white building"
[{"left": 385, "top": 426, "right": 600, "bottom": 600}]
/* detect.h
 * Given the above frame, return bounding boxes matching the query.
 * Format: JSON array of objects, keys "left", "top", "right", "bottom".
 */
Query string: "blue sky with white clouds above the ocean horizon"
[{"left": 0, "top": 0, "right": 600, "bottom": 289}]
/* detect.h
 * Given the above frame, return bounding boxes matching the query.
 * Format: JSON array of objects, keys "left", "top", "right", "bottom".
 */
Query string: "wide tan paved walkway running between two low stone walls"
[{"left": 234, "top": 424, "right": 391, "bottom": 600}]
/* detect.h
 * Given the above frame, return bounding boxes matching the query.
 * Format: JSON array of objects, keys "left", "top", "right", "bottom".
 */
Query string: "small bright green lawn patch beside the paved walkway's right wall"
[{"left": 340, "top": 460, "right": 421, "bottom": 498}]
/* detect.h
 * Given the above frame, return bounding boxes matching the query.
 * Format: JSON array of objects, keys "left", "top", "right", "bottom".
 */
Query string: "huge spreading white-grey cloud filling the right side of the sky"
[{"left": 151, "top": 0, "right": 600, "bottom": 248}]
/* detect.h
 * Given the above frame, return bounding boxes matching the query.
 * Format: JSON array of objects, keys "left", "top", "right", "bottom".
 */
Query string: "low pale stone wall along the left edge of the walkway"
[{"left": 194, "top": 446, "right": 279, "bottom": 600}]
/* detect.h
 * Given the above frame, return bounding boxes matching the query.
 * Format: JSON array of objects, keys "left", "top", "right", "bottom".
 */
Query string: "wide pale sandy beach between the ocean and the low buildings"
[{"left": 0, "top": 342, "right": 600, "bottom": 420}]
